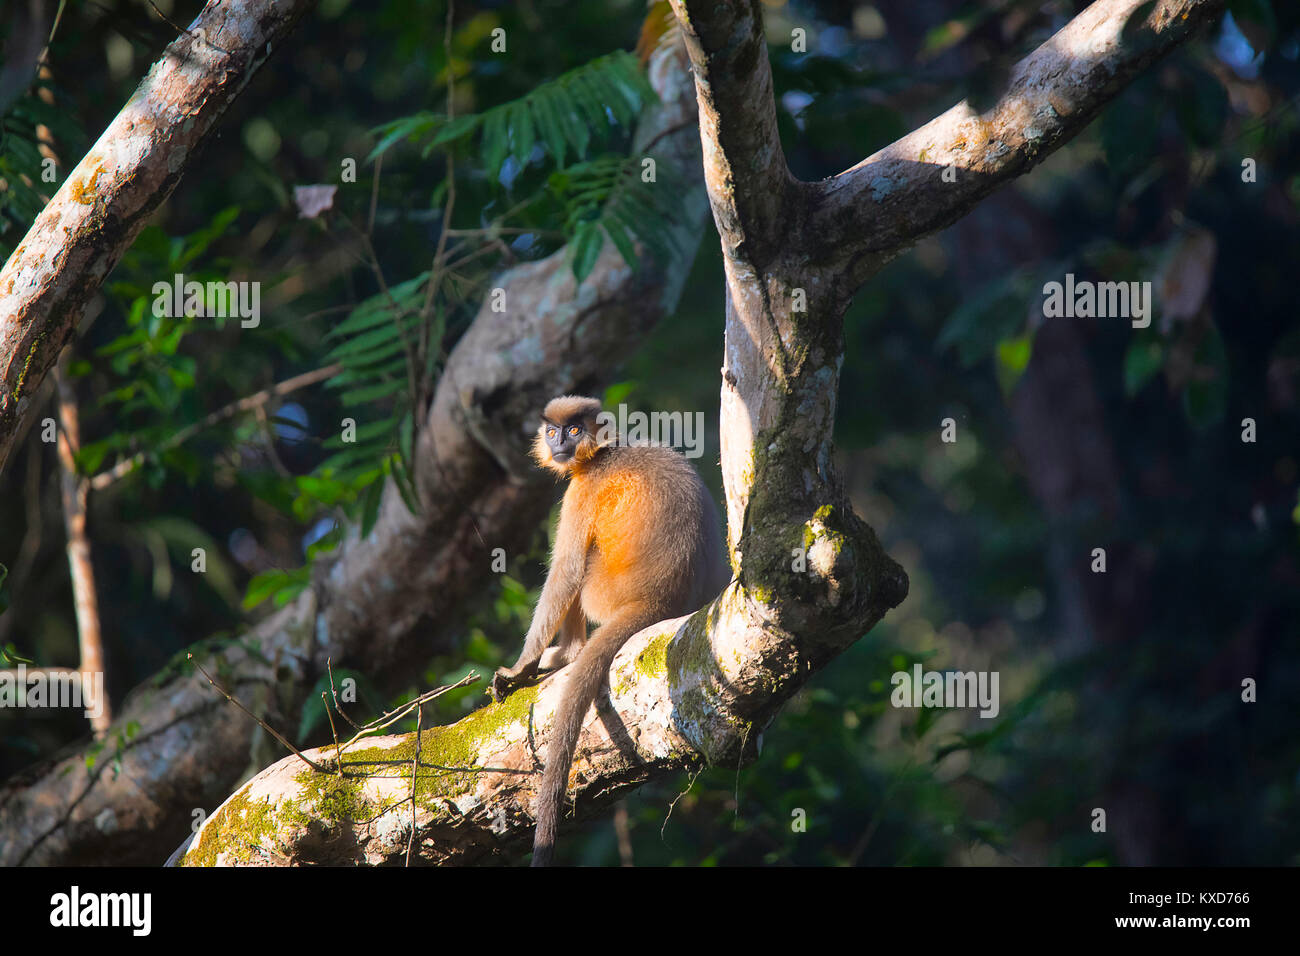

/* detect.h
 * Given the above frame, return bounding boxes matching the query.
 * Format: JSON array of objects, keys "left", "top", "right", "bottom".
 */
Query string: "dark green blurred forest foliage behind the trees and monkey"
[{"left": 0, "top": 0, "right": 1300, "bottom": 865}]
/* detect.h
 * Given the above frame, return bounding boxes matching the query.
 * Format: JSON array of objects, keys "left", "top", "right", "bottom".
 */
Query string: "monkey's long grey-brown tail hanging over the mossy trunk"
[{"left": 532, "top": 615, "right": 644, "bottom": 866}]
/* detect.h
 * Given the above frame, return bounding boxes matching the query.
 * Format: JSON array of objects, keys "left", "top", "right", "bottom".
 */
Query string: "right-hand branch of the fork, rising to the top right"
[{"left": 800, "top": 0, "right": 1225, "bottom": 294}]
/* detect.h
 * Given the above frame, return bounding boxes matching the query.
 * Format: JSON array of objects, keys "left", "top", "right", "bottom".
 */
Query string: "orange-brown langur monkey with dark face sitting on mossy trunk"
[{"left": 491, "top": 395, "right": 729, "bottom": 866}]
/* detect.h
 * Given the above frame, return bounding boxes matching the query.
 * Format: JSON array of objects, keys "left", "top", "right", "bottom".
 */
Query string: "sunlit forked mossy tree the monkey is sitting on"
[{"left": 185, "top": 0, "right": 1223, "bottom": 865}]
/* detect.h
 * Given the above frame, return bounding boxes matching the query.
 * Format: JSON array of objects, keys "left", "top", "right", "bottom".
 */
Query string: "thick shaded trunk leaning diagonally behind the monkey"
[{"left": 0, "top": 20, "right": 709, "bottom": 865}]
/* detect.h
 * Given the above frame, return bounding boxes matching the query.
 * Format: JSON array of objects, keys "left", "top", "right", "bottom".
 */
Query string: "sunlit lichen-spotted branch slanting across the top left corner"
[{"left": 0, "top": 0, "right": 316, "bottom": 471}]
